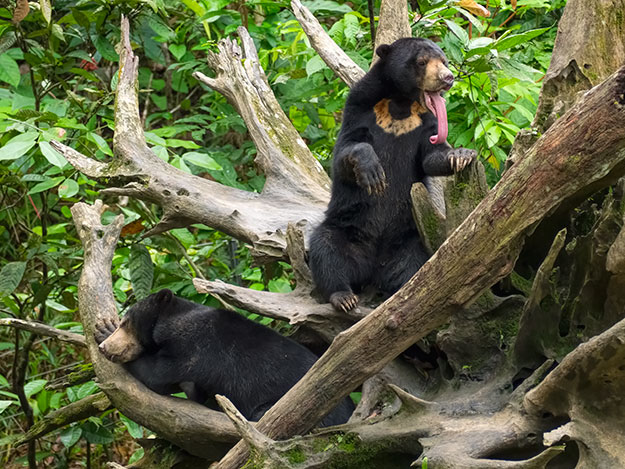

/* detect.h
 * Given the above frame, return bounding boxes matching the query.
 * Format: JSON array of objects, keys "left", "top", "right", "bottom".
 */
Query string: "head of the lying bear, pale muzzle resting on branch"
[{"left": 99, "top": 290, "right": 176, "bottom": 363}]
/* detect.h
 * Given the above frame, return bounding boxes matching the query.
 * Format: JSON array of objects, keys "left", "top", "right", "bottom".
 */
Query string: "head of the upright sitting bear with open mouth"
[{"left": 376, "top": 37, "right": 454, "bottom": 100}]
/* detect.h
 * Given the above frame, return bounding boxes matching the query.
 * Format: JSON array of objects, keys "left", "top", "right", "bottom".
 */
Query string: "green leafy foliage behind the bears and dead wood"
[{"left": 0, "top": 0, "right": 564, "bottom": 467}]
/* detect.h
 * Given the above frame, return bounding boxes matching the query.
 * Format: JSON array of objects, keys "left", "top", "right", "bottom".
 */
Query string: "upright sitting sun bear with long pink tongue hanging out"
[{"left": 309, "top": 38, "right": 476, "bottom": 311}]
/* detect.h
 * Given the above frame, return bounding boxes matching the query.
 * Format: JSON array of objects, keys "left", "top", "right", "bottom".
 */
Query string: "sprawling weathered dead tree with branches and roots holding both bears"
[{"left": 54, "top": 0, "right": 625, "bottom": 469}]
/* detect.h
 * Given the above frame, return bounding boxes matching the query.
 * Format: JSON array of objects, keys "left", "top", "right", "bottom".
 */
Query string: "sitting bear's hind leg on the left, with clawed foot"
[{"left": 309, "top": 224, "right": 373, "bottom": 311}]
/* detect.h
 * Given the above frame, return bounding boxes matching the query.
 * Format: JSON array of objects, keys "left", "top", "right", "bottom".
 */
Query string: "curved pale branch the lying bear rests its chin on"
[{"left": 71, "top": 200, "right": 237, "bottom": 458}]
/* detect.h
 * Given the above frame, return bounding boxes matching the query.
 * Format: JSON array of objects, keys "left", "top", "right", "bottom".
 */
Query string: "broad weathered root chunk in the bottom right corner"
[{"left": 524, "top": 320, "right": 625, "bottom": 468}]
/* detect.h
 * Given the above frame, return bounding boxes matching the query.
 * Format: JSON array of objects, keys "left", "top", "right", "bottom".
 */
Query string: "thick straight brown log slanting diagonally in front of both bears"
[{"left": 213, "top": 67, "right": 625, "bottom": 469}]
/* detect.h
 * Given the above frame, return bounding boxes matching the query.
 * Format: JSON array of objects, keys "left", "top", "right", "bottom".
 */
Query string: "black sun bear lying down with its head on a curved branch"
[{"left": 95, "top": 290, "right": 354, "bottom": 426}]
